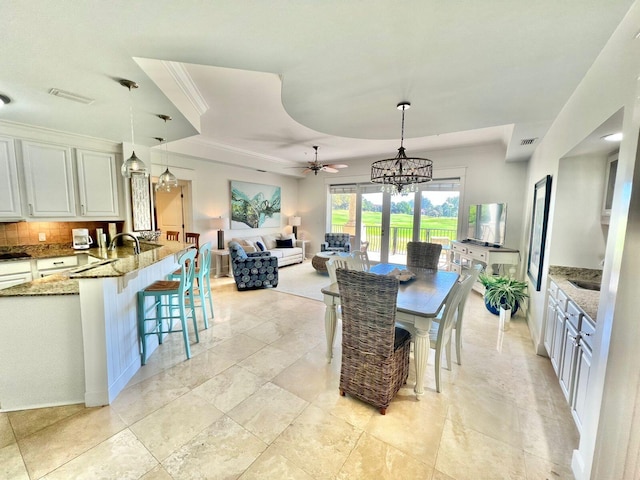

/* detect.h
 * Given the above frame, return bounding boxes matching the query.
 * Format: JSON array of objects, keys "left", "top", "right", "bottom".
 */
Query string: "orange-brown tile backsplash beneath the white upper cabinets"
[{"left": 0, "top": 221, "right": 124, "bottom": 246}]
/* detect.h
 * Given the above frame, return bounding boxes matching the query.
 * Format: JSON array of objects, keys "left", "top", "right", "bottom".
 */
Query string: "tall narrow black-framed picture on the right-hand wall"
[{"left": 527, "top": 175, "right": 551, "bottom": 292}]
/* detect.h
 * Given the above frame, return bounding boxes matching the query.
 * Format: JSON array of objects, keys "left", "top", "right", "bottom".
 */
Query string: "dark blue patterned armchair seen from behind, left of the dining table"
[{"left": 229, "top": 242, "right": 278, "bottom": 290}]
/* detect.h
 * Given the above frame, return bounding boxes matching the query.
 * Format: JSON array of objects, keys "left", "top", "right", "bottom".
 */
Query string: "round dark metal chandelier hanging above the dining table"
[{"left": 371, "top": 102, "right": 433, "bottom": 193}]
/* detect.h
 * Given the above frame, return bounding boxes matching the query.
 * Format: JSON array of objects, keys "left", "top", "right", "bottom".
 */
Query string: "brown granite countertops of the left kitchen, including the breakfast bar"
[{"left": 0, "top": 242, "right": 193, "bottom": 297}]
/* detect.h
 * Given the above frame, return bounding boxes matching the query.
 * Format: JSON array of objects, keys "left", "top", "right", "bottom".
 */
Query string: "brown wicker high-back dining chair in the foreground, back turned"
[{"left": 336, "top": 268, "right": 411, "bottom": 415}]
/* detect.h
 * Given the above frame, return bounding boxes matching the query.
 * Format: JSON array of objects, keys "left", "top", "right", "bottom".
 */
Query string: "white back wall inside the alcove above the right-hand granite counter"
[{"left": 548, "top": 154, "right": 609, "bottom": 269}]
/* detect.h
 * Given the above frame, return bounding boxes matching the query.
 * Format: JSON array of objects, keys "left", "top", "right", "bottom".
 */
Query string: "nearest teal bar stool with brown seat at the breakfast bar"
[{"left": 138, "top": 248, "right": 200, "bottom": 365}]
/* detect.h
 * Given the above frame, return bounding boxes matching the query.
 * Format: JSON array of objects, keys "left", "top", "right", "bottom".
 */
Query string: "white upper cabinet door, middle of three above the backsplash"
[{"left": 22, "top": 141, "right": 76, "bottom": 217}]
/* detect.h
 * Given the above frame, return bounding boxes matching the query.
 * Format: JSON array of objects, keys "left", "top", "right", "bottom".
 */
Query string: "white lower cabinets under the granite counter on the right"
[{"left": 544, "top": 280, "right": 595, "bottom": 432}]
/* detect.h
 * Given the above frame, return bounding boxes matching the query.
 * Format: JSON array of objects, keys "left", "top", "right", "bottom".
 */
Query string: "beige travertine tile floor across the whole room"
[{"left": 0, "top": 272, "right": 578, "bottom": 480}]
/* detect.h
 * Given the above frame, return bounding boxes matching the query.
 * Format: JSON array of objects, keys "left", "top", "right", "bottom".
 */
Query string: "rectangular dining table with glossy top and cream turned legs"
[{"left": 322, "top": 263, "right": 459, "bottom": 399}]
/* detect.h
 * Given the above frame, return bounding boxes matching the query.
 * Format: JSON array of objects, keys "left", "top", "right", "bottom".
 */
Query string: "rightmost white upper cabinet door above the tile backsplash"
[{"left": 76, "top": 149, "right": 119, "bottom": 218}]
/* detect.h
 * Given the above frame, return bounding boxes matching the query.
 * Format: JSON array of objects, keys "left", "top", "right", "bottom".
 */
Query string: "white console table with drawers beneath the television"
[{"left": 451, "top": 241, "right": 520, "bottom": 290}]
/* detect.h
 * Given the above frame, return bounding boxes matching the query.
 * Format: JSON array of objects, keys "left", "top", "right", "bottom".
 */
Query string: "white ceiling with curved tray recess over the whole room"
[{"left": 0, "top": 0, "right": 633, "bottom": 174}]
